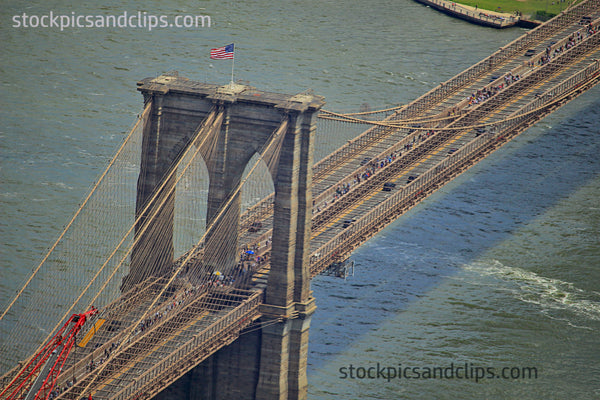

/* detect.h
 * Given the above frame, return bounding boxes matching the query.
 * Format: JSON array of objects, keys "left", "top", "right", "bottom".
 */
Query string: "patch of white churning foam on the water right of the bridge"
[{"left": 463, "top": 259, "right": 600, "bottom": 326}]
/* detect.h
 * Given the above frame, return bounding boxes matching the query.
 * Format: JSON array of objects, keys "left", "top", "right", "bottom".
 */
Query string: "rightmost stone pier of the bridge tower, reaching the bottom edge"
[{"left": 256, "top": 96, "right": 316, "bottom": 400}]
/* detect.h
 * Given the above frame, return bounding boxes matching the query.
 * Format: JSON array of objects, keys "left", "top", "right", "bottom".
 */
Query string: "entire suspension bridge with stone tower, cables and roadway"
[{"left": 0, "top": 0, "right": 600, "bottom": 400}]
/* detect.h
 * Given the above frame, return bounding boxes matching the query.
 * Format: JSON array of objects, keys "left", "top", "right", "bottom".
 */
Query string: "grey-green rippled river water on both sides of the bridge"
[{"left": 0, "top": 0, "right": 600, "bottom": 399}]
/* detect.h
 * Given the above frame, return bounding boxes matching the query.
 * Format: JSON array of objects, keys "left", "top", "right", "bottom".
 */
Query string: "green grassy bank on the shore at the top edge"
[{"left": 458, "top": 0, "right": 571, "bottom": 20}]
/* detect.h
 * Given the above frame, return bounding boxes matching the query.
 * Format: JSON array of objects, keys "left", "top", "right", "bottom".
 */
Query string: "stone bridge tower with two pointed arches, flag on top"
[{"left": 123, "top": 74, "right": 324, "bottom": 400}]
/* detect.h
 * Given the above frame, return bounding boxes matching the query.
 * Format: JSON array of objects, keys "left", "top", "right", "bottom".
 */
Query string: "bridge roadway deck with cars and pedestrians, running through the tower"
[{"left": 3, "top": 0, "right": 600, "bottom": 399}]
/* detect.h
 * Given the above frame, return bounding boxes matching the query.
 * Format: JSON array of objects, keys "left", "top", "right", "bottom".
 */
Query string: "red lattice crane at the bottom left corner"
[{"left": 0, "top": 306, "right": 98, "bottom": 400}]
